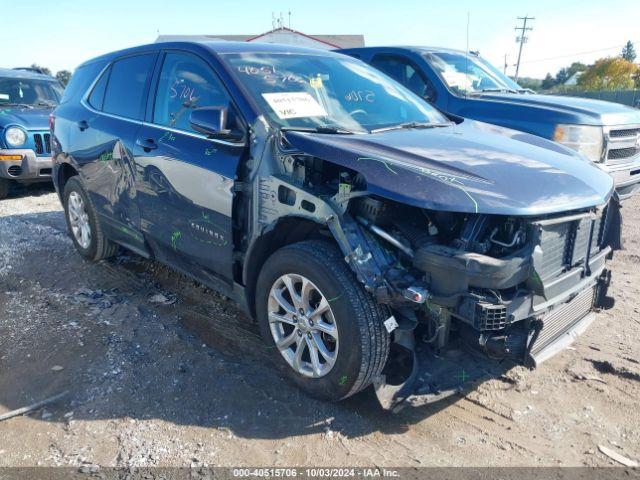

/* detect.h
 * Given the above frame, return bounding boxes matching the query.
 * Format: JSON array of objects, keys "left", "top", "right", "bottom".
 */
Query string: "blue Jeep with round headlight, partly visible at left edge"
[{"left": 0, "top": 68, "right": 63, "bottom": 199}]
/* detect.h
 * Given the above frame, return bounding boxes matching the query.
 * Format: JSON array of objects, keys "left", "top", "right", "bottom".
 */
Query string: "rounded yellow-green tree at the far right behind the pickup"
[{"left": 578, "top": 57, "right": 640, "bottom": 90}]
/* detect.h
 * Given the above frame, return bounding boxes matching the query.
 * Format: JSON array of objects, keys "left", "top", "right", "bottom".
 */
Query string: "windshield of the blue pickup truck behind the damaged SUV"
[{"left": 426, "top": 52, "right": 523, "bottom": 94}]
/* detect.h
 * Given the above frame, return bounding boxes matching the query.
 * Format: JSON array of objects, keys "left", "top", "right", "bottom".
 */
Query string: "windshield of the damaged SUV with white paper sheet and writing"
[{"left": 222, "top": 53, "right": 448, "bottom": 132}]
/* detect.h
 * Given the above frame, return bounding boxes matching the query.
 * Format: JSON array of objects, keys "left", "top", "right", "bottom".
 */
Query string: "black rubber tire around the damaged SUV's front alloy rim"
[{"left": 256, "top": 240, "right": 390, "bottom": 401}]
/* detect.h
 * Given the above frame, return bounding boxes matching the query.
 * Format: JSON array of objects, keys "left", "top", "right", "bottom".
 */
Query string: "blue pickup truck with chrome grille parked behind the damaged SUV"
[{"left": 339, "top": 46, "right": 640, "bottom": 199}]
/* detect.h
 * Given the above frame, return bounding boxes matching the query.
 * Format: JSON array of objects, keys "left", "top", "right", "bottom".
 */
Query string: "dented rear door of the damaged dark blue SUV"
[{"left": 72, "top": 52, "right": 157, "bottom": 250}]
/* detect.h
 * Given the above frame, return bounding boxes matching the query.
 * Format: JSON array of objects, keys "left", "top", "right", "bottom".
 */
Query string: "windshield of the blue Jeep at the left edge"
[{"left": 0, "top": 77, "right": 62, "bottom": 107}]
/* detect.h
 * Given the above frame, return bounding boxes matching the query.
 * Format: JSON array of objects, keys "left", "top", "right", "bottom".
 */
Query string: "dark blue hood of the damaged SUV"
[{"left": 286, "top": 120, "right": 613, "bottom": 215}]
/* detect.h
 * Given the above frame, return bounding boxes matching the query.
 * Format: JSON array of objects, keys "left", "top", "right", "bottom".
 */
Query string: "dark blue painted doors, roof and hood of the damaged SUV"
[{"left": 53, "top": 42, "right": 612, "bottom": 300}]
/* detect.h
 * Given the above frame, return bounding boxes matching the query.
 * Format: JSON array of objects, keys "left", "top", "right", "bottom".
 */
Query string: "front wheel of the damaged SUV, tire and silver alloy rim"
[{"left": 256, "top": 240, "right": 390, "bottom": 401}]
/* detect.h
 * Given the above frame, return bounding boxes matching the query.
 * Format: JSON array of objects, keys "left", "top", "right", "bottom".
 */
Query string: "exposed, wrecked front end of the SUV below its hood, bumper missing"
[{"left": 330, "top": 197, "right": 620, "bottom": 409}]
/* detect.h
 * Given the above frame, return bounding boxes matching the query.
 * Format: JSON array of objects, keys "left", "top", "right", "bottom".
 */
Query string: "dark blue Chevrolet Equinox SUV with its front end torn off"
[{"left": 52, "top": 42, "right": 620, "bottom": 409}]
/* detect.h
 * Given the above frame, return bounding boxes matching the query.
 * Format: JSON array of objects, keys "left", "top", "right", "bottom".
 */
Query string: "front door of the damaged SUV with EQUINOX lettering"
[{"left": 134, "top": 50, "right": 245, "bottom": 284}]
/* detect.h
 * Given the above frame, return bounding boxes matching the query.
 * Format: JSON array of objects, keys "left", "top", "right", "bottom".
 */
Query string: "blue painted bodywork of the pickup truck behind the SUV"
[{"left": 339, "top": 46, "right": 640, "bottom": 200}]
